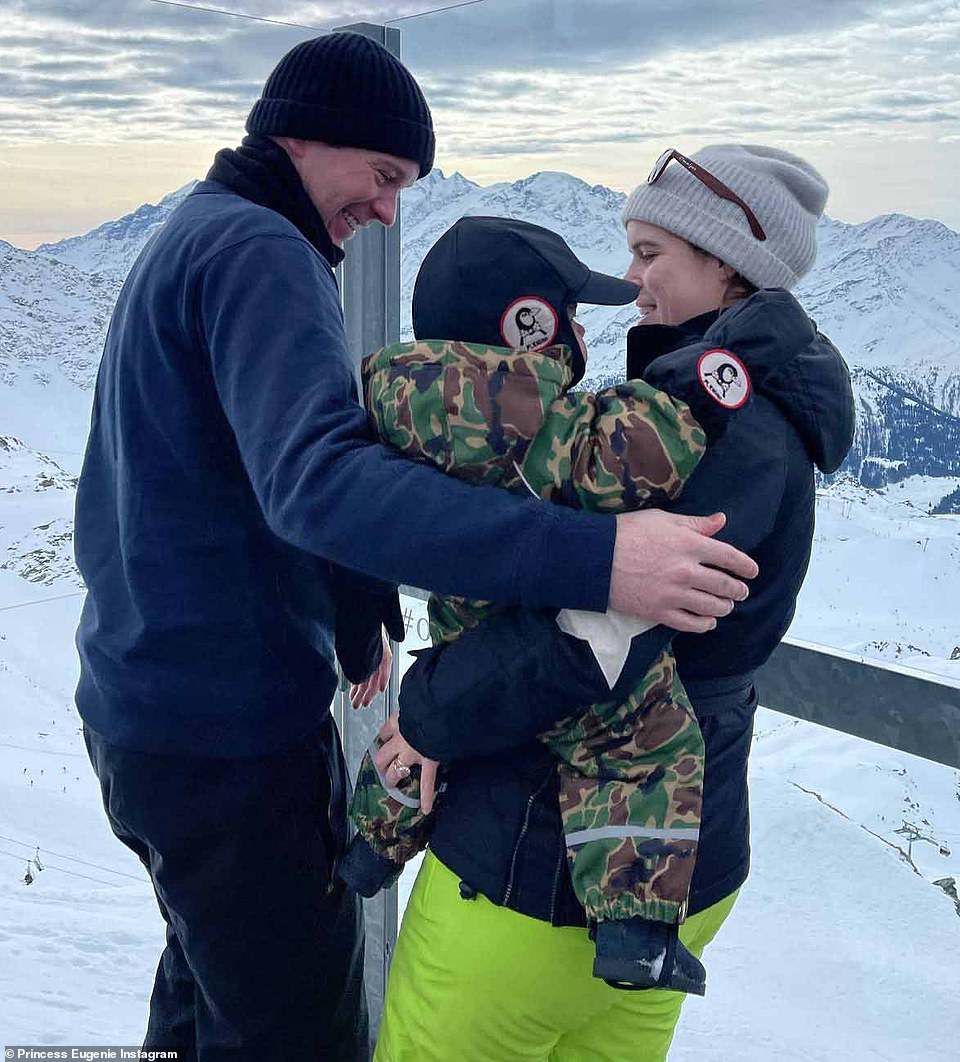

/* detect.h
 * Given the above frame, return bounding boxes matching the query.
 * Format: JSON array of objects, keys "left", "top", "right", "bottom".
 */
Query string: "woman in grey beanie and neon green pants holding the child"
[{"left": 369, "top": 144, "right": 853, "bottom": 1062}]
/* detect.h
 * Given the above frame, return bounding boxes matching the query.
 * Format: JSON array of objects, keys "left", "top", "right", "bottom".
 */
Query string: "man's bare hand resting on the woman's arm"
[{"left": 610, "top": 509, "right": 759, "bottom": 634}]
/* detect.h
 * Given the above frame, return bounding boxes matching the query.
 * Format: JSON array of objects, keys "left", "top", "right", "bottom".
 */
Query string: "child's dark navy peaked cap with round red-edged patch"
[{"left": 413, "top": 218, "right": 639, "bottom": 382}]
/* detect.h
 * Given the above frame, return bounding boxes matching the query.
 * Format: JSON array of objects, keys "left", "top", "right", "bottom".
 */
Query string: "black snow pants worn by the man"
[{"left": 84, "top": 717, "right": 368, "bottom": 1062}]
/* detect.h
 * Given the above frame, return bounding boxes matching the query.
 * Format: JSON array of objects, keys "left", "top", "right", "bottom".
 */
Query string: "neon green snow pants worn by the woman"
[{"left": 374, "top": 851, "right": 737, "bottom": 1062}]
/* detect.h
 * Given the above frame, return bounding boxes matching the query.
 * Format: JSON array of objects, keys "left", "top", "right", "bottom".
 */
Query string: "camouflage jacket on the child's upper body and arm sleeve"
[{"left": 362, "top": 340, "right": 743, "bottom": 643}]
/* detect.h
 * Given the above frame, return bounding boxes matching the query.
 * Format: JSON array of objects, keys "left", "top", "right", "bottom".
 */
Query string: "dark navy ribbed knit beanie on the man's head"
[{"left": 246, "top": 33, "right": 435, "bottom": 177}]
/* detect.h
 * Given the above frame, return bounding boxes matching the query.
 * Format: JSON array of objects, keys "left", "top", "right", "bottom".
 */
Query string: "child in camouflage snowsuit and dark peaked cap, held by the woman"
[{"left": 340, "top": 218, "right": 750, "bottom": 995}]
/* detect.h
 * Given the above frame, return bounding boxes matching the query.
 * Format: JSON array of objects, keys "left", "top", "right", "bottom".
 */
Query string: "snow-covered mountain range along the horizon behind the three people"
[{"left": 11, "top": 170, "right": 960, "bottom": 486}]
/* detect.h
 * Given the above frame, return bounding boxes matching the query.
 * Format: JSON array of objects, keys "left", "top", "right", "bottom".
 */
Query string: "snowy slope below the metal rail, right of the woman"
[{"left": 670, "top": 712, "right": 960, "bottom": 1062}]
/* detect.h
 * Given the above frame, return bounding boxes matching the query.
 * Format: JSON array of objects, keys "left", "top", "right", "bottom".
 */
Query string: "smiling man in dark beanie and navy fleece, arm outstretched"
[{"left": 76, "top": 34, "right": 756, "bottom": 1062}]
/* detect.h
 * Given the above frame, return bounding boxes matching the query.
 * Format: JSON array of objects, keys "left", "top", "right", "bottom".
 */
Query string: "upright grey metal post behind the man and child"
[{"left": 335, "top": 22, "right": 400, "bottom": 1038}]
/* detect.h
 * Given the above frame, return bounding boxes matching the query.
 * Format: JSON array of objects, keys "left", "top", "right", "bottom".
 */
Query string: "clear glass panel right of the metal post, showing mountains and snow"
[{"left": 390, "top": 0, "right": 960, "bottom": 1062}]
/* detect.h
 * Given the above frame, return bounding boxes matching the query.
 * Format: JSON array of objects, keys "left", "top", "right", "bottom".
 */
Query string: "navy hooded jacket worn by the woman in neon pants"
[{"left": 400, "top": 291, "right": 854, "bottom": 925}]
